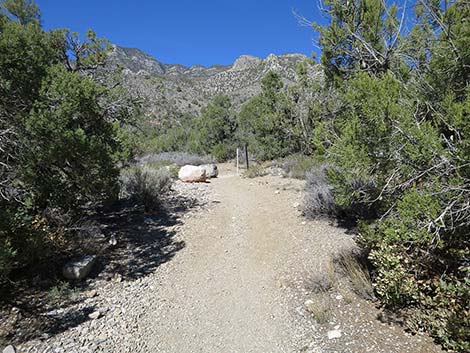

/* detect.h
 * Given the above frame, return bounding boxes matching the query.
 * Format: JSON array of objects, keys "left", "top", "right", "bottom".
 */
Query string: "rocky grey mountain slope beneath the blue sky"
[{"left": 107, "top": 46, "right": 320, "bottom": 120}]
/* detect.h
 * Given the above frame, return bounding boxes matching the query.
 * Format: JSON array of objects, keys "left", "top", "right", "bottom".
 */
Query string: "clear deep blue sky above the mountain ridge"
[{"left": 36, "top": 0, "right": 322, "bottom": 65}]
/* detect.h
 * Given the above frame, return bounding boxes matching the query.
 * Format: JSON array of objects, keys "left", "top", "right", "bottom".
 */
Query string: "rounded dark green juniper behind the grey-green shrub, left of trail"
[{"left": 22, "top": 66, "right": 118, "bottom": 210}]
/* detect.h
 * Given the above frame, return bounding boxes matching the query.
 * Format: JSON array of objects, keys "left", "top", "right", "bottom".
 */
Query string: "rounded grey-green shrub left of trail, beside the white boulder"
[{"left": 121, "top": 166, "right": 172, "bottom": 211}]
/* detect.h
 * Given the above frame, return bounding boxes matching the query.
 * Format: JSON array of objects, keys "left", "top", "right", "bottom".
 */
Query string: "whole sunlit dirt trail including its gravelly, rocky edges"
[{"left": 13, "top": 165, "right": 439, "bottom": 353}]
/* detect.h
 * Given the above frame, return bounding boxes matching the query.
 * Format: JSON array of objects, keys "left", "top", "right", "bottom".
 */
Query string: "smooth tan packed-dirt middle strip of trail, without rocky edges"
[{"left": 145, "top": 166, "right": 306, "bottom": 352}]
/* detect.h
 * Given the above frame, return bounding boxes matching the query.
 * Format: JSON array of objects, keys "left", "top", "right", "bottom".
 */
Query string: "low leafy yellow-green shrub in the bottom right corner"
[{"left": 361, "top": 189, "right": 470, "bottom": 351}]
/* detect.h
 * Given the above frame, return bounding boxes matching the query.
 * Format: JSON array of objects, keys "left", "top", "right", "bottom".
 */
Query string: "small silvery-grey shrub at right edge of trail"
[{"left": 302, "top": 165, "right": 336, "bottom": 218}]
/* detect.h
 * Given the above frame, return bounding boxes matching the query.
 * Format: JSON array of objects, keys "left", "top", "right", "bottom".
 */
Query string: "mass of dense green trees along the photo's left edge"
[{"left": 0, "top": 0, "right": 135, "bottom": 276}]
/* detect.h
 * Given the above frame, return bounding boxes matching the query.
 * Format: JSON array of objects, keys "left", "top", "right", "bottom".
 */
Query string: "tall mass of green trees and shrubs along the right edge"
[{"left": 313, "top": 0, "right": 470, "bottom": 351}]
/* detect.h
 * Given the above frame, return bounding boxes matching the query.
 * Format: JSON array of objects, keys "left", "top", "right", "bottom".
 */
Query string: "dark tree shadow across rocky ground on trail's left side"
[{"left": 0, "top": 190, "right": 201, "bottom": 346}]
